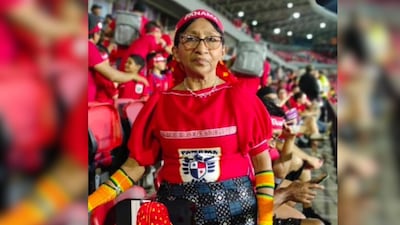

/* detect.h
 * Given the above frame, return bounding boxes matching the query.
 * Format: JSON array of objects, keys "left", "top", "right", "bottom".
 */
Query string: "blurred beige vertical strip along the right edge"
[{"left": 338, "top": 1, "right": 400, "bottom": 225}]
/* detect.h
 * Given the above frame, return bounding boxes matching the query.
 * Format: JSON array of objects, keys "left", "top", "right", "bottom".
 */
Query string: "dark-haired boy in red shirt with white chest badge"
[{"left": 118, "top": 55, "right": 150, "bottom": 100}]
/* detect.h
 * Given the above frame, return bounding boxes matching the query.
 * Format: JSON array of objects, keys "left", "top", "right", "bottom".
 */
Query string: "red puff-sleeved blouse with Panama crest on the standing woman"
[{"left": 128, "top": 83, "right": 272, "bottom": 183}]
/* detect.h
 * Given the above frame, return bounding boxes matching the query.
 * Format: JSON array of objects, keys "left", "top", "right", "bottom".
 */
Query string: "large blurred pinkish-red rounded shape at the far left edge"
[{"left": 0, "top": 74, "right": 57, "bottom": 172}]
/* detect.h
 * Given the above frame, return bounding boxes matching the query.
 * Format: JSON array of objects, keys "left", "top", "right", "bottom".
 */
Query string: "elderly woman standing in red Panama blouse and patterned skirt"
[{"left": 89, "top": 10, "right": 274, "bottom": 225}]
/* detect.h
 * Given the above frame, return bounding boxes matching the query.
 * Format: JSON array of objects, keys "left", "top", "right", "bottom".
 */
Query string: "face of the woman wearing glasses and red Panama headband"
[{"left": 173, "top": 18, "right": 225, "bottom": 77}]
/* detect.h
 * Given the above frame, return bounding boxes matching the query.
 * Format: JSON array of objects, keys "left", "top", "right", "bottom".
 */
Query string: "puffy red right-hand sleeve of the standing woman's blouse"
[{"left": 232, "top": 81, "right": 272, "bottom": 156}]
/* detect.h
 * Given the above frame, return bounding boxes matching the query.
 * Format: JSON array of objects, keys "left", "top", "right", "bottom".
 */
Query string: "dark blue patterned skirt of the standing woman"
[{"left": 157, "top": 176, "right": 257, "bottom": 225}]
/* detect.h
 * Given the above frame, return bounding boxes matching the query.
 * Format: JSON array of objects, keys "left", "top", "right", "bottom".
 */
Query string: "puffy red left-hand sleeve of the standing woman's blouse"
[{"left": 128, "top": 91, "right": 161, "bottom": 166}]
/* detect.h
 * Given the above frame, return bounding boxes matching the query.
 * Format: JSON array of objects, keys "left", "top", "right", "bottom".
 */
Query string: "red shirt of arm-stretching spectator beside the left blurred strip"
[{"left": 88, "top": 41, "right": 104, "bottom": 102}]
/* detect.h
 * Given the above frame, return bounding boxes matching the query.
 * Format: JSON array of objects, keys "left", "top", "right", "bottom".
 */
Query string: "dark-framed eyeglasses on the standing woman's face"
[{"left": 180, "top": 34, "right": 224, "bottom": 50}]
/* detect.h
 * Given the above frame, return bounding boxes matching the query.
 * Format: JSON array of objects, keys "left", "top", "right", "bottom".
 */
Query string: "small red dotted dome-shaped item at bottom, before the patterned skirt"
[{"left": 136, "top": 202, "right": 172, "bottom": 225}]
